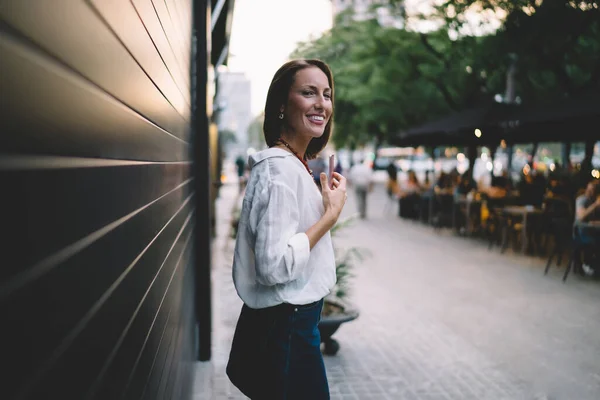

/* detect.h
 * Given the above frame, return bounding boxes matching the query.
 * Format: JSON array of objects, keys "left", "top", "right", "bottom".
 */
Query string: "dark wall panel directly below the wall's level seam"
[{"left": 0, "top": 162, "right": 189, "bottom": 288}]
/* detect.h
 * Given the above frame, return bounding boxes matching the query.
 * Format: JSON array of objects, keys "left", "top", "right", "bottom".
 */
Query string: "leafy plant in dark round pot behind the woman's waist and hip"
[{"left": 319, "top": 216, "right": 366, "bottom": 355}]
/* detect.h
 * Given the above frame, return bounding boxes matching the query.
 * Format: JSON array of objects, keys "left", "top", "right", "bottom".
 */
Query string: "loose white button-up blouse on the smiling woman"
[{"left": 233, "top": 147, "right": 336, "bottom": 308}]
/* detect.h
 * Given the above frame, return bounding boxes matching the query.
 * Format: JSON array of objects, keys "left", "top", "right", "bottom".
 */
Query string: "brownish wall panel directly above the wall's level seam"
[{"left": 0, "top": 35, "right": 189, "bottom": 161}]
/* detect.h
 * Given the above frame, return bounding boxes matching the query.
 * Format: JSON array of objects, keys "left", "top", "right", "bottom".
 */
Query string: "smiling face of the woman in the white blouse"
[{"left": 280, "top": 67, "right": 333, "bottom": 138}]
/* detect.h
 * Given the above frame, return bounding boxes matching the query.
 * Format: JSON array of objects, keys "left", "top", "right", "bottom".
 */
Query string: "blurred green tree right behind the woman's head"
[{"left": 292, "top": 16, "right": 503, "bottom": 148}]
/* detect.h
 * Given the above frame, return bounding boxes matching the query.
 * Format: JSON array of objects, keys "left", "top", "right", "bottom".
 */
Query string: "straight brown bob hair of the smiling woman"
[{"left": 263, "top": 59, "right": 334, "bottom": 160}]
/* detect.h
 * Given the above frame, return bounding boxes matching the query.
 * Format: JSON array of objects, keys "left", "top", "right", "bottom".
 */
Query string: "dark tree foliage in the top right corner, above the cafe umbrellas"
[{"left": 429, "top": 0, "right": 600, "bottom": 103}]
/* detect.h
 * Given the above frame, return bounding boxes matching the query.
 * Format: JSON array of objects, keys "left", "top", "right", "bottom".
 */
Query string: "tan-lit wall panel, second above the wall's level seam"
[{"left": 0, "top": 0, "right": 188, "bottom": 137}]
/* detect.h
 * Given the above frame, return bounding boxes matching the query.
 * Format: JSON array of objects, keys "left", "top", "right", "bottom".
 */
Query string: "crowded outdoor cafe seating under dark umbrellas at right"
[{"left": 394, "top": 93, "right": 600, "bottom": 280}]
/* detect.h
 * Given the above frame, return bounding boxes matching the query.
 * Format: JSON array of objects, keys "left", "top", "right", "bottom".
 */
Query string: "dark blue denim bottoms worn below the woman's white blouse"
[{"left": 227, "top": 300, "right": 329, "bottom": 400}]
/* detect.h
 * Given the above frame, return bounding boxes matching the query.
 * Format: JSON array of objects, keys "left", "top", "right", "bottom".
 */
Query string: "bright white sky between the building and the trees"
[{"left": 229, "top": 0, "right": 332, "bottom": 115}]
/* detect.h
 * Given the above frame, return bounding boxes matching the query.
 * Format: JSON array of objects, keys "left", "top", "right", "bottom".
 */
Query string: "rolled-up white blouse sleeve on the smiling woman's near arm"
[{"left": 250, "top": 183, "right": 310, "bottom": 286}]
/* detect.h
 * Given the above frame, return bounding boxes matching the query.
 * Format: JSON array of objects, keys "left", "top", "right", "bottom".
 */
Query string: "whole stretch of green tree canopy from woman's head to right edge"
[{"left": 292, "top": 0, "right": 600, "bottom": 147}]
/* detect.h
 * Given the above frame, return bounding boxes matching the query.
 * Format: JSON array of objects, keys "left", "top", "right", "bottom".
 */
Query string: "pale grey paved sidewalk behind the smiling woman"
[{"left": 194, "top": 166, "right": 600, "bottom": 400}]
